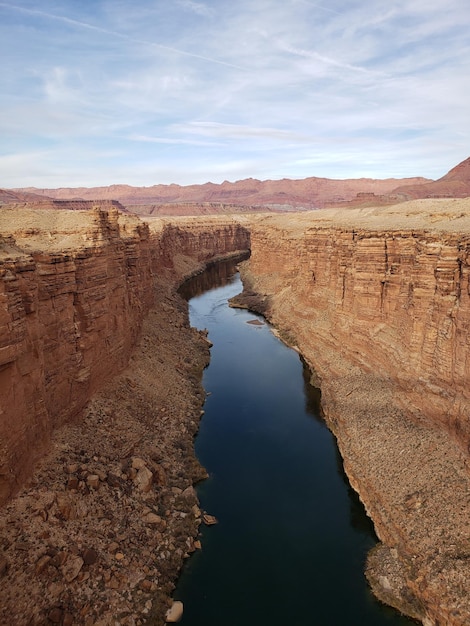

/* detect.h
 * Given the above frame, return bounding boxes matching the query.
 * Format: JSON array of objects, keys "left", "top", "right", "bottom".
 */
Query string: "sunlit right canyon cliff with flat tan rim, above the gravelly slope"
[{"left": 239, "top": 200, "right": 470, "bottom": 449}]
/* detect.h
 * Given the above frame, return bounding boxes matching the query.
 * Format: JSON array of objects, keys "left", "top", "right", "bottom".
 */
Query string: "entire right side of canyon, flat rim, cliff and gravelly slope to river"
[{"left": 236, "top": 199, "right": 470, "bottom": 626}]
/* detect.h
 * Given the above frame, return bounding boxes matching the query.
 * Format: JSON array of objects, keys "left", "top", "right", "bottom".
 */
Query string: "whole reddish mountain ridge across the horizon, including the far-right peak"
[{"left": 6, "top": 158, "right": 470, "bottom": 215}]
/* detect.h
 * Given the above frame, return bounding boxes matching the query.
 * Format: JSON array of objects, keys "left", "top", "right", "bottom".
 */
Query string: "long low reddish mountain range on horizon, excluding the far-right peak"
[{"left": 10, "top": 171, "right": 429, "bottom": 215}]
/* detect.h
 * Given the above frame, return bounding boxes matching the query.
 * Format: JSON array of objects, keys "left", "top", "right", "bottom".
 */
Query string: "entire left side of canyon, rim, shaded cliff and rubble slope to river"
[{"left": 0, "top": 208, "right": 249, "bottom": 625}]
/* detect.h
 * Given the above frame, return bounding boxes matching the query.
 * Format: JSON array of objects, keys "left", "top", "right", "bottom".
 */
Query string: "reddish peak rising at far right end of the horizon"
[{"left": 393, "top": 157, "right": 470, "bottom": 199}]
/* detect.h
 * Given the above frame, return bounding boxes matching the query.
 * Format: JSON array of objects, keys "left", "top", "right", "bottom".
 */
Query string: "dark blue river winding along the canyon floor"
[{"left": 175, "top": 264, "right": 414, "bottom": 626}]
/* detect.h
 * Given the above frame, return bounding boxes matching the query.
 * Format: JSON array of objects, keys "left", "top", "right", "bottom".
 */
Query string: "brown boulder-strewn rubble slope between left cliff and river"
[{"left": 0, "top": 285, "right": 209, "bottom": 626}]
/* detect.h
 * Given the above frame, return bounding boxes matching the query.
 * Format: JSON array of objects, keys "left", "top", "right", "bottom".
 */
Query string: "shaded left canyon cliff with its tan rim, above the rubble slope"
[{"left": 0, "top": 207, "right": 249, "bottom": 504}]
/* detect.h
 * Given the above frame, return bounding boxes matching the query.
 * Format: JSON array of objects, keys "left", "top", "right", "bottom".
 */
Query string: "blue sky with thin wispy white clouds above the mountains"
[{"left": 0, "top": 0, "right": 470, "bottom": 188}]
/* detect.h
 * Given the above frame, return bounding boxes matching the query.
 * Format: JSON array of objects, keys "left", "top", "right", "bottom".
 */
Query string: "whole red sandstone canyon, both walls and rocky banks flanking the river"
[{"left": 0, "top": 199, "right": 470, "bottom": 626}]
